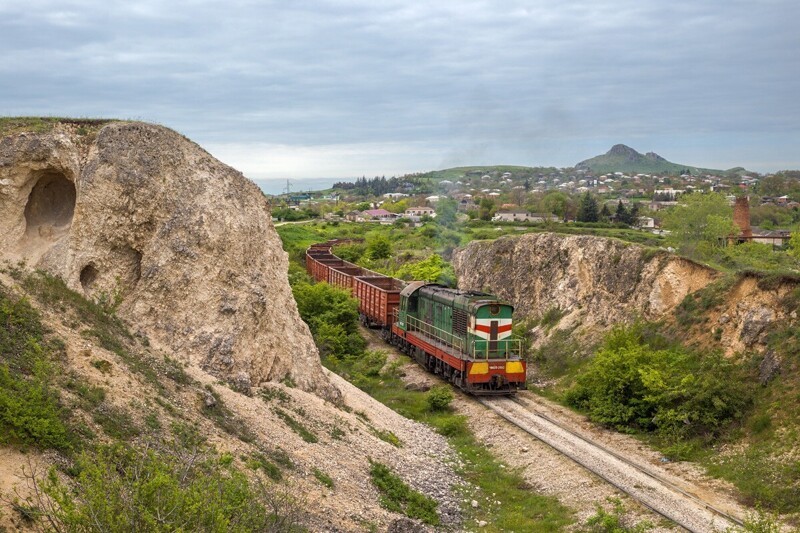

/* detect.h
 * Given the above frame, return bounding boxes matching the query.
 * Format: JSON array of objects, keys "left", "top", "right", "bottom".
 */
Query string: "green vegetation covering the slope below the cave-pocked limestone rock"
[{"left": 0, "top": 267, "right": 301, "bottom": 532}]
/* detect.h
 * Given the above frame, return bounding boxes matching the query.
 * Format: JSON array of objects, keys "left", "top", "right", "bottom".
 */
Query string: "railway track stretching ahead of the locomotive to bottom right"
[{"left": 478, "top": 392, "right": 742, "bottom": 533}]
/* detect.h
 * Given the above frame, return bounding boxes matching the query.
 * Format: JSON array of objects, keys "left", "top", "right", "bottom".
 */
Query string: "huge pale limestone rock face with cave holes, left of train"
[{"left": 0, "top": 122, "right": 339, "bottom": 399}]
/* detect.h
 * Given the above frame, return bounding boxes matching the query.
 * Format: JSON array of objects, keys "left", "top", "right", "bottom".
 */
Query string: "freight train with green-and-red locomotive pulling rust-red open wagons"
[{"left": 306, "top": 240, "right": 526, "bottom": 395}]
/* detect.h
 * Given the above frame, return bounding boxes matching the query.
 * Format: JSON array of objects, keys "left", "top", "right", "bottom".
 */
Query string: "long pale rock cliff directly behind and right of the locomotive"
[{"left": 453, "top": 233, "right": 717, "bottom": 326}]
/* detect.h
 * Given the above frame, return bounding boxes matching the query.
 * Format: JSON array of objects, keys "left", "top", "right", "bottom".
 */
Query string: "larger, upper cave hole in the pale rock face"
[{"left": 25, "top": 170, "right": 75, "bottom": 236}]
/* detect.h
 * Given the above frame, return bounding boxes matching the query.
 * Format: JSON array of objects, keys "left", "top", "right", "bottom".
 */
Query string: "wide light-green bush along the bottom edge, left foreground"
[{"left": 39, "top": 445, "right": 298, "bottom": 532}]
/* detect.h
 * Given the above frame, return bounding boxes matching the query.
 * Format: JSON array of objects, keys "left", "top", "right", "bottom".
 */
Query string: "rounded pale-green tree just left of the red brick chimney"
[{"left": 662, "top": 193, "right": 739, "bottom": 250}]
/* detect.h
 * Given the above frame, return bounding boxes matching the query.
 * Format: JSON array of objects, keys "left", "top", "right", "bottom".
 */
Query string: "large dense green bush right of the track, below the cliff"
[{"left": 565, "top": 326, "right": 752, "bottom": 438}]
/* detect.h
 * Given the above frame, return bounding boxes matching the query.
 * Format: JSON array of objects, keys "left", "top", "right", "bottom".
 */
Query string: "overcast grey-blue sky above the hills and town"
[{"left": 0, "top": 0, "right": 800, "bottom": 178}]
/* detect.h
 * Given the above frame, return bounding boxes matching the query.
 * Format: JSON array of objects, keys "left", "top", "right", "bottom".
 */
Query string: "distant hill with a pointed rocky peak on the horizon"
[{"left": 575, "top": 144, "right": 725, "bottom": 174}]
